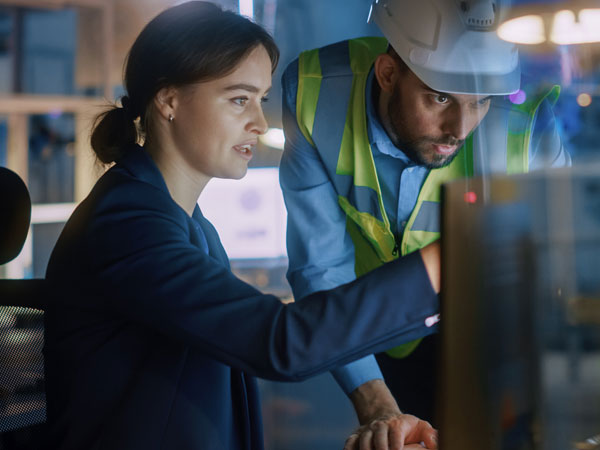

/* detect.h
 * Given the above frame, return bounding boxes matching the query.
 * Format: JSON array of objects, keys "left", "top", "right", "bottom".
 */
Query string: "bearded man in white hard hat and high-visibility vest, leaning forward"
[{"left": 280, "top": 0, "right": 570, "bottom": 448}]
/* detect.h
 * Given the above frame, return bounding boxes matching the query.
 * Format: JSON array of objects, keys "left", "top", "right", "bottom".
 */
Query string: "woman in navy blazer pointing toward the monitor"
[{"left": 45, "top": 2, "right": 438, "bottom": 450}]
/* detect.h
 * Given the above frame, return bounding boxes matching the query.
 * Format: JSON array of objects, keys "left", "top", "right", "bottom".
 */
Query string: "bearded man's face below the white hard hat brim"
[{"left": 387, "top": 68, "right": 490, "bottom": 169}]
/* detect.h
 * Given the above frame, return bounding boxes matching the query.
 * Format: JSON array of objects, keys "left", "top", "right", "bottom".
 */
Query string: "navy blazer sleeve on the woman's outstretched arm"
[{"left": 69, "top": 176, "right": 438, "bottom": 380}]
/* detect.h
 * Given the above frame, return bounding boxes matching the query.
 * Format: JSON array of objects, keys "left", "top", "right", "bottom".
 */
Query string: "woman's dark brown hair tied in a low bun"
[{"left": 91, "top": 1, "right": 279, "bottom": 164}]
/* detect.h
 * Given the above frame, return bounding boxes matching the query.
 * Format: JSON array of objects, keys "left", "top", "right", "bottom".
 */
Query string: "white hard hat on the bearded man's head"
[{"left": 369, "top": 0, "right": 521, "bottom": 95}]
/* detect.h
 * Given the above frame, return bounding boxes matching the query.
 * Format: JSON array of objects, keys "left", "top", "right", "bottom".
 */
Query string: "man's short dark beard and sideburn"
[{"left": 388, "top": 86, "right": 464, "bottom": 169}]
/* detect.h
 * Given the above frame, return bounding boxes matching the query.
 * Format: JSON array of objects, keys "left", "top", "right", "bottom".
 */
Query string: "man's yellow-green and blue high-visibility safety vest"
[{"left": 296, "top": 38, "right": 559, "bottom": 357}]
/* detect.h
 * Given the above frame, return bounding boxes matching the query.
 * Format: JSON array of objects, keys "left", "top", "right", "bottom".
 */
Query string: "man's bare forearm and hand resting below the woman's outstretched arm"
[{"left": 344, "top": 380, "right": 437, "bottom": 450}]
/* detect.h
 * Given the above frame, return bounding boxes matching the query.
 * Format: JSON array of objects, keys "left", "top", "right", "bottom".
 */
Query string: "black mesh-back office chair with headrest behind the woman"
[{"left": 0, "top": 167, "right": 49, "bottom": 450}]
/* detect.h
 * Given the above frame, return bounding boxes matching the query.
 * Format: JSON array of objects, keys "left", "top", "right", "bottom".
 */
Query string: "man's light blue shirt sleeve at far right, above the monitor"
[{"left": 529, "top": 99, "right": 571, "bottom": 170}]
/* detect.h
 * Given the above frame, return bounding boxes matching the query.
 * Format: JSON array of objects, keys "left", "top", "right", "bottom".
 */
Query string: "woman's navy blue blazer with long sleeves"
[{"left": 44, "top": 146, "right": 438, "bottom": 450}]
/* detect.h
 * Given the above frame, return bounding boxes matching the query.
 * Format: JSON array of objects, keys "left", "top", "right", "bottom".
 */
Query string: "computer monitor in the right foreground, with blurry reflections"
[{"left": 437, "top": 166, "right": 600, "bottom": 450}]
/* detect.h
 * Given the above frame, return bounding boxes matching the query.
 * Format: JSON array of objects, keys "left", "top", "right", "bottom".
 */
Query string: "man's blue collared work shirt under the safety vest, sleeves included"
[{"left": 280, "top": 55, "right": 570, "bottom": 394}]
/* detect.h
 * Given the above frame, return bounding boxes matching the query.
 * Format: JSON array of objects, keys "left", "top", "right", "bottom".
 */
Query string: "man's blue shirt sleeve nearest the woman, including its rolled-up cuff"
[{"left": 279, "top": 60, "right": 383, "bottom": 394}]
